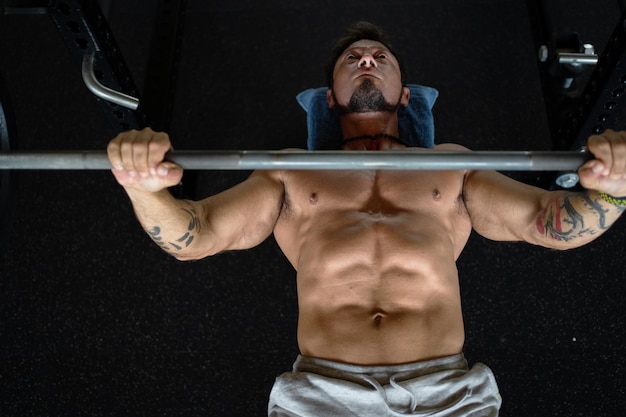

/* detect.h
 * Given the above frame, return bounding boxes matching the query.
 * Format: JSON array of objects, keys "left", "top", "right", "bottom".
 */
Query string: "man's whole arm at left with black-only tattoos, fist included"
[{"left": 107, "top": 129, "right": 284, "bottom": 260}]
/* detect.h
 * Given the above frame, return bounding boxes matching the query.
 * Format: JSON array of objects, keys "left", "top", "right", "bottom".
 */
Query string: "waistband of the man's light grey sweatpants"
[{"left": 293, "top": 353, "right": 468, "bottom": 380}]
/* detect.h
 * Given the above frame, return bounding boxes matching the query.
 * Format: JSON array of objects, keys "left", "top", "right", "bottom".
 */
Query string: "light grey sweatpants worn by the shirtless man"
[{"left": 268, "top": 354, "right": 502, "bottom": 417}]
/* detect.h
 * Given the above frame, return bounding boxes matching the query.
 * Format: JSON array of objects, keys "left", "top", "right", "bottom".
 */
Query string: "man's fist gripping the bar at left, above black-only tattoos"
[{"left": 107, "top": 128, "right": 183, "bottom": 192}]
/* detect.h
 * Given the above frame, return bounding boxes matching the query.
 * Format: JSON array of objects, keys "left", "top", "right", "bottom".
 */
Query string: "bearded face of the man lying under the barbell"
[{"left": 328, "top": 39, "right": 408, "bottom": 114}]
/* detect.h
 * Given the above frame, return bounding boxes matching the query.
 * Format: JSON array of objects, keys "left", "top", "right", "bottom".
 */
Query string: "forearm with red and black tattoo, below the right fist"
[{"left": 536, "top": 191, "right": 626, "bottom": 249}]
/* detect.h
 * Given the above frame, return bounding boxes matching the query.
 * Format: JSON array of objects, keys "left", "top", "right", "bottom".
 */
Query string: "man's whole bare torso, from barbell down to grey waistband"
[{"left": 274, "top": 164, "right": 471, "bottom": 365}]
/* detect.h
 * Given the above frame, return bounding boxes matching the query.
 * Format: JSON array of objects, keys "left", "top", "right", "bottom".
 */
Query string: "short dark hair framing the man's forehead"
[{"left": 326, "top": 21, "right": 405, "bottom": 88}]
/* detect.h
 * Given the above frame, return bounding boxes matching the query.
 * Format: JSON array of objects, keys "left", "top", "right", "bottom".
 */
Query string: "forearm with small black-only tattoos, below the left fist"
[{"left": 126, "top": 189, "right": 202, "bottom": 260}]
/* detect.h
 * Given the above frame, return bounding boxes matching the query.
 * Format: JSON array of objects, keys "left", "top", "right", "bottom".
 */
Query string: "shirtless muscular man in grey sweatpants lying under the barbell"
[{"left": 108, "top": 23, "right": 626, "bottom": 417}]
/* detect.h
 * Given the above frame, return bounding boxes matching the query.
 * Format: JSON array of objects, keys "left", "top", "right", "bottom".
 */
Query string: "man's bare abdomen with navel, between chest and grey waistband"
[{"left": 286, "top": 208, "right": 464, "bottom": 365}]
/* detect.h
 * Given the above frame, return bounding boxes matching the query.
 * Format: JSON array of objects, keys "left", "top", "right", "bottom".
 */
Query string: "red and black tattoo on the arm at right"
[{"left": 537, "top": 193, "right": 623, "bottom": 242}]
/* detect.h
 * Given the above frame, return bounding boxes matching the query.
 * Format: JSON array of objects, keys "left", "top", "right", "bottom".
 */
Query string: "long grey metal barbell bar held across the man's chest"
[{"left": 0, "top": 150, "right": 590, "bottom": 171}]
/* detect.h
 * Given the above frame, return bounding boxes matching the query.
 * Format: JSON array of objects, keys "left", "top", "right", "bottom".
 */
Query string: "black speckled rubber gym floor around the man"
[{"left": 0, "top": 0, "right": 626, "bottom": 417}]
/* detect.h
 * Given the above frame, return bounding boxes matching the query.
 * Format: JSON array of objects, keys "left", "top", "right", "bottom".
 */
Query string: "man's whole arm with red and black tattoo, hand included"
[{"left": 464, "top": 130, "right": 626, "bottom": 249}]
